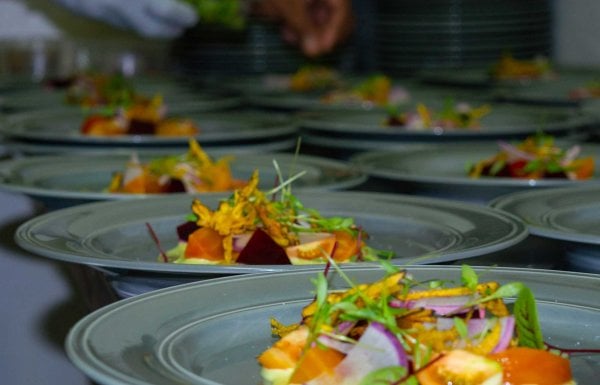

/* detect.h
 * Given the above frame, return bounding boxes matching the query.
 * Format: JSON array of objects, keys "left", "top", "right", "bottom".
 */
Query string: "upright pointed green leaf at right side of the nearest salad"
[{"left": 513, "top": 286, "right": 545, "bottom": 349}]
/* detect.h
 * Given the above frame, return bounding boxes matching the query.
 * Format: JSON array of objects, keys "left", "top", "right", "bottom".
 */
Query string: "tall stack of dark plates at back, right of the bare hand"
[{"left": 376, "top": 0, "right": 552, "bottom": 73}]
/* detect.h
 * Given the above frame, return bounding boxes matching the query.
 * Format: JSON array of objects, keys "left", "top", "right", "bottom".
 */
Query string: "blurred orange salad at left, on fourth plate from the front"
[{"left": 80, "top": 95, "right": 200, "bottom": 136}]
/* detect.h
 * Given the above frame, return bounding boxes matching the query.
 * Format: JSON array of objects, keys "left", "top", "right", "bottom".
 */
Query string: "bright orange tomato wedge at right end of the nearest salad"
[{"left": 490, "top": 347, "right": 572, "bottom": 385}]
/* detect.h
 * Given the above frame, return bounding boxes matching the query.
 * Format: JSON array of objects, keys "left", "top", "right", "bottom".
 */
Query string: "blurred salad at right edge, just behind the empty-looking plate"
[{"left": 468, "top": 133, "right": 594, "bottom": 180}]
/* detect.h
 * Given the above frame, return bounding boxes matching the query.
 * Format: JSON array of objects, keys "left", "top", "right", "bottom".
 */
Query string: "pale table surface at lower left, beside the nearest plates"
[{"left": 0, "top": 192, "right": 91, "bottom": 385}]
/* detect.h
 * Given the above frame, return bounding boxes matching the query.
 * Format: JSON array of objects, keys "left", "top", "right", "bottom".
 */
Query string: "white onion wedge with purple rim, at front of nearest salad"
[{"left": 307, "top": 322, "right": 408, "bottom": 385}]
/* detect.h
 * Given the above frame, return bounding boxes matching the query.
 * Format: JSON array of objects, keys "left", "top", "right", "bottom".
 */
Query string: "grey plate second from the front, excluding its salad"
[{"left": 15, "top": 192, "right": 527, "bottom": 275}]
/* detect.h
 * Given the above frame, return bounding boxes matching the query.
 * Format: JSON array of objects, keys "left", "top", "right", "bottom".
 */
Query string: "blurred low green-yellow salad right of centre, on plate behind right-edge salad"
[{"left": 384, "top": 100, "right": 491, "bottom": 131}]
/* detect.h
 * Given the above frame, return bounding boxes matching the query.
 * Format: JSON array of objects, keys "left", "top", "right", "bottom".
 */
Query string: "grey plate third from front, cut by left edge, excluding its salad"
[{"left": 0, "top": 150, "right": 366, "bottom": 207}]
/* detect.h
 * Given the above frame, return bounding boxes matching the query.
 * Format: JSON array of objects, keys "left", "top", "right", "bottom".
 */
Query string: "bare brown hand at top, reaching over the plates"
[{"left": 254, "top": 0, "right": 354, "bottom": 56}]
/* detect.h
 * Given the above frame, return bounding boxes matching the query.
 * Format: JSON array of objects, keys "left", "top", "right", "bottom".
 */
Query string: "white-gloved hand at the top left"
[{"left": 54, "top": 0, "right": 198, "bottom": 38}]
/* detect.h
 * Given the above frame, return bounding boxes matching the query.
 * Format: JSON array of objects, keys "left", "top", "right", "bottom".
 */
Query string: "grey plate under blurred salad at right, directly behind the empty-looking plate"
[{"left": 351, "top": 141, "right": 600, "bottom": 203}]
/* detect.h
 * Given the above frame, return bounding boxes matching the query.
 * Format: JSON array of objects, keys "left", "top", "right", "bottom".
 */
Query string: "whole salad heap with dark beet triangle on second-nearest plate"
[{"left": 160, "top": 171, "right": 391, "bottom": 265}]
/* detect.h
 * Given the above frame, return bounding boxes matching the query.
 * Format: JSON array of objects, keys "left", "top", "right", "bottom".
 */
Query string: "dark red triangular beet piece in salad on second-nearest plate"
[{"left": 237, "top": 229, "right": 290, "bottom": 265}]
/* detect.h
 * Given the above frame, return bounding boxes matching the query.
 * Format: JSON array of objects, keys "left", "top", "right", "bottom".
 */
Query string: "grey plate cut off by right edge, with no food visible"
[{"left": 490, "top": 186, "right": 600, "bottom": 273}]
